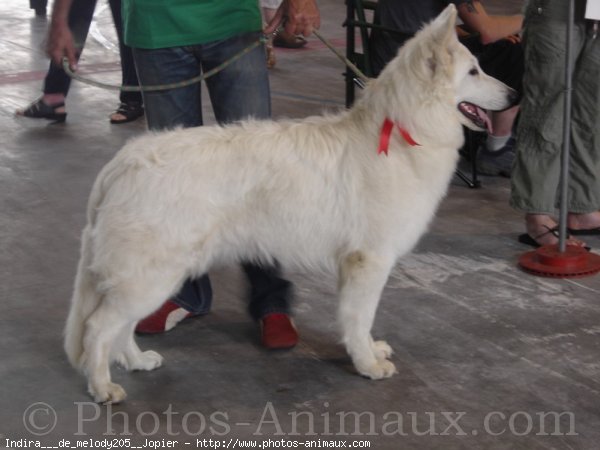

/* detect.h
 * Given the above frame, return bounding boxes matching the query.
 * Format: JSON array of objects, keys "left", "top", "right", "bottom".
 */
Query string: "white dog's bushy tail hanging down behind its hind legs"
[{"left": 64, "top": 226, "right": 101, "bottom": 369}]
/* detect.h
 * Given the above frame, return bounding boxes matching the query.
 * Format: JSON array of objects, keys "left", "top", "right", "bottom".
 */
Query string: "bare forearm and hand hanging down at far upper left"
[{"left": 46, "top": 0, "right": 77, "bottom": 69}]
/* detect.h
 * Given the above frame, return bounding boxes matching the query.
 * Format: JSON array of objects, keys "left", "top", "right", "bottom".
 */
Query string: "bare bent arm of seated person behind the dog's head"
[{"left": 458, "top": 0, "right": 523, "bottom": 45}]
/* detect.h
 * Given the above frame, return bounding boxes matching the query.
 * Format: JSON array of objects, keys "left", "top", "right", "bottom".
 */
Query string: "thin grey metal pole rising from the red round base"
[{"left": 558, "top": 0, "right": 575, "bottom": 253}]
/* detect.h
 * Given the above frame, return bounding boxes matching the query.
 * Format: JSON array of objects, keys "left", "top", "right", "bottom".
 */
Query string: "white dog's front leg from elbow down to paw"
[{"left": 338, "top": 252, "right": 396, "bottom": 380}]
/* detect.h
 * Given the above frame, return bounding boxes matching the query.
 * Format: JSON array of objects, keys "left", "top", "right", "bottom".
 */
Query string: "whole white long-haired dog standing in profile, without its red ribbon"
[{"left": 65, "top": 6, "right": 512, "bottom": 402}]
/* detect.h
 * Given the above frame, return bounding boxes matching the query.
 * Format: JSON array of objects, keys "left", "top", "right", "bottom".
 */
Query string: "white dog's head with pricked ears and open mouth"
[{"left": 372, "top": 4, "right": 517, "bottom": 131}]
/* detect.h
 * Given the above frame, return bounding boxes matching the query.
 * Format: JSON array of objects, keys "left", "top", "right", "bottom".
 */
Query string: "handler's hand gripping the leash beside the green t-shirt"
[{"left": 264, "top": 0, "right": 321, "bottom": 37}]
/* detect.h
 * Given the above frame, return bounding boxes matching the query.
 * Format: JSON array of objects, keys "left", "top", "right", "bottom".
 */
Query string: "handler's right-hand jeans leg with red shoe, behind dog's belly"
[{"left": 202, "top": 33, "right": 298, "bottom": 348}]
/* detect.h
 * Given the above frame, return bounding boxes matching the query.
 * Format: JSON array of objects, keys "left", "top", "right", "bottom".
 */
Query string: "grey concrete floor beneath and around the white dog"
[{"left": 0, "top": 0, "right": 600, "bottom": 450}]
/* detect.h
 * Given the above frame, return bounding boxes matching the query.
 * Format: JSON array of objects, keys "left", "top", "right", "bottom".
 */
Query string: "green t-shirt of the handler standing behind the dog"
[{"left": 123, "top": 0, "right": 262, "bottom": 49}]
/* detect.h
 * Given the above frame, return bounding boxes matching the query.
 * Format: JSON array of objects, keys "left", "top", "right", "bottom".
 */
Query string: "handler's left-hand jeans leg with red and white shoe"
[{"left": 133, "top": 47, "right": 212, "bottom": 333}]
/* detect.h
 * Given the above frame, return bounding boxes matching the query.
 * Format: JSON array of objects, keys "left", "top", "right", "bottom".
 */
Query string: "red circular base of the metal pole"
[{"left": 519, "top": 245, "right": 600, "bottom": 278}]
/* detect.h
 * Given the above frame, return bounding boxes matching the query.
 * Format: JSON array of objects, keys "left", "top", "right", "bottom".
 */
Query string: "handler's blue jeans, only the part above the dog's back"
[{"left": 133, "top": 33, "right": 271, "bottom": 130}]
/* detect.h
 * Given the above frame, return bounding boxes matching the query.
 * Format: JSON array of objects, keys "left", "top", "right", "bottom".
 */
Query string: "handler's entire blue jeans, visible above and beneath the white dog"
[{"left": 133, "top": 32, "right": 291, "bottom": 320}]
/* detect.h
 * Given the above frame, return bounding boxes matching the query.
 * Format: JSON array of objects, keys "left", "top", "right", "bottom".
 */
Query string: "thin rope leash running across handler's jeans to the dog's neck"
[{"left": 63, "top": 30, "right": 369, "bottom": 92}]
